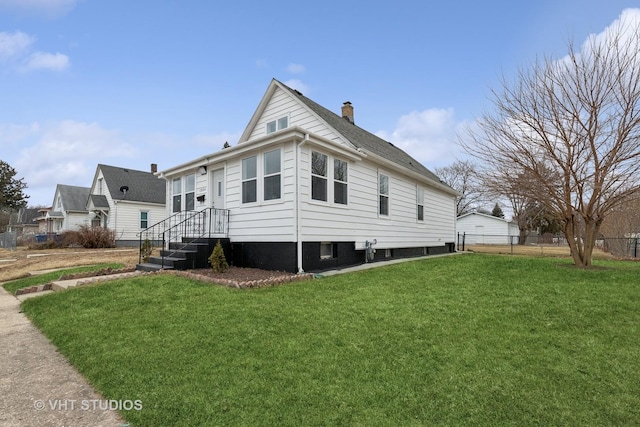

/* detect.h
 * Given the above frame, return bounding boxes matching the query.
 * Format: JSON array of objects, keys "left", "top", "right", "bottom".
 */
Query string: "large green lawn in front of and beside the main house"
[{"left": 23, "top": 254, "right": 640, "bottom": 426}]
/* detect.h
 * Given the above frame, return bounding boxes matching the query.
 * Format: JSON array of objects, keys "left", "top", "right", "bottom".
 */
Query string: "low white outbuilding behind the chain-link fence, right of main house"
[{"left": 457, "top": 212, "right": 520, "bottom": 245}]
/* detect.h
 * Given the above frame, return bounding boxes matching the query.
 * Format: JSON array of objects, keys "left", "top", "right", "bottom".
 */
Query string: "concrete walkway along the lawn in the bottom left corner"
[{"left": 0, "top": 287, "right": 126, "bottom": 427}]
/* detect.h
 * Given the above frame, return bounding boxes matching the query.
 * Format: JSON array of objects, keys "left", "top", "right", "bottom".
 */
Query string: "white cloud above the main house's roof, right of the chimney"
[{"left": 377, "top": 108, "right": 462, "bottom": 168}]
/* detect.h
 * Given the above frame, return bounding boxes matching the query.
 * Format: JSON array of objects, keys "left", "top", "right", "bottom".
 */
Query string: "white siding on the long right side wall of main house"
[{"left": 299, "top": 147, "right": 455, "bottom": 248}]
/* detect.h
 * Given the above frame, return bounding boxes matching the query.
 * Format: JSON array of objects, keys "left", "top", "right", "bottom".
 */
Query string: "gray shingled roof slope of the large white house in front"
[{"left": 278, "top": 81, "right": 446, "bottom": 185}]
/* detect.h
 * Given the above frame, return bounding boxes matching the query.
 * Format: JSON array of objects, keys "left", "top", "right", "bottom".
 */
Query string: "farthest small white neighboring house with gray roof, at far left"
[{"left": 37, "top": 184, "right": 89, "bottom": 234}]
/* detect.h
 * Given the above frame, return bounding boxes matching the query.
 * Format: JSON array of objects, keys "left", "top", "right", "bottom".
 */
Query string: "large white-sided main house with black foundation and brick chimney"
[{"left": 153, "top": 79, "right": 457, "bottom": 272}]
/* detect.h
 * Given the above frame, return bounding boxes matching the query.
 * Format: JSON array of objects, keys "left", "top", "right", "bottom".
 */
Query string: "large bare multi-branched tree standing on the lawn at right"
[{"left": 461, "top": 19, "right": 640, "bottom": 267}]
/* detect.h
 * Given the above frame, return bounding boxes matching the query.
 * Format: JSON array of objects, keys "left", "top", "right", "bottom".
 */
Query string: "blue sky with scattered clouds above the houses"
[{"left": 0, "top": 0, "right": 640, "bottom": 206}]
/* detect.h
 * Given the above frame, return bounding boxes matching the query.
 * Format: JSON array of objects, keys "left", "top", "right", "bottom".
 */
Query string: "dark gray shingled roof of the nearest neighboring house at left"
[{"left": 98, "top": 165, "right": 166, "bottom": 204}]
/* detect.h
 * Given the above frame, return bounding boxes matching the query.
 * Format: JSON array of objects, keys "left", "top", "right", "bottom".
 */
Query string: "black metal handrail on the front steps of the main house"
[{"left": 139, "top": 208, "right": 229, "bottom": 268}]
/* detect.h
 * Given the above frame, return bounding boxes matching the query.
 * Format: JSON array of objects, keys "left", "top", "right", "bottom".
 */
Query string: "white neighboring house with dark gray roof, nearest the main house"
[{"left": 85, "top": 164, "right": 166, "bottom": 246}]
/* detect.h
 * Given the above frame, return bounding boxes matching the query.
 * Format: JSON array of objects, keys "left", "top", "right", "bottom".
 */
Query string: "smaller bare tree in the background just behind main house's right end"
[{"left": 435, "top": 160, "right": 484, "bottom": 216}]
